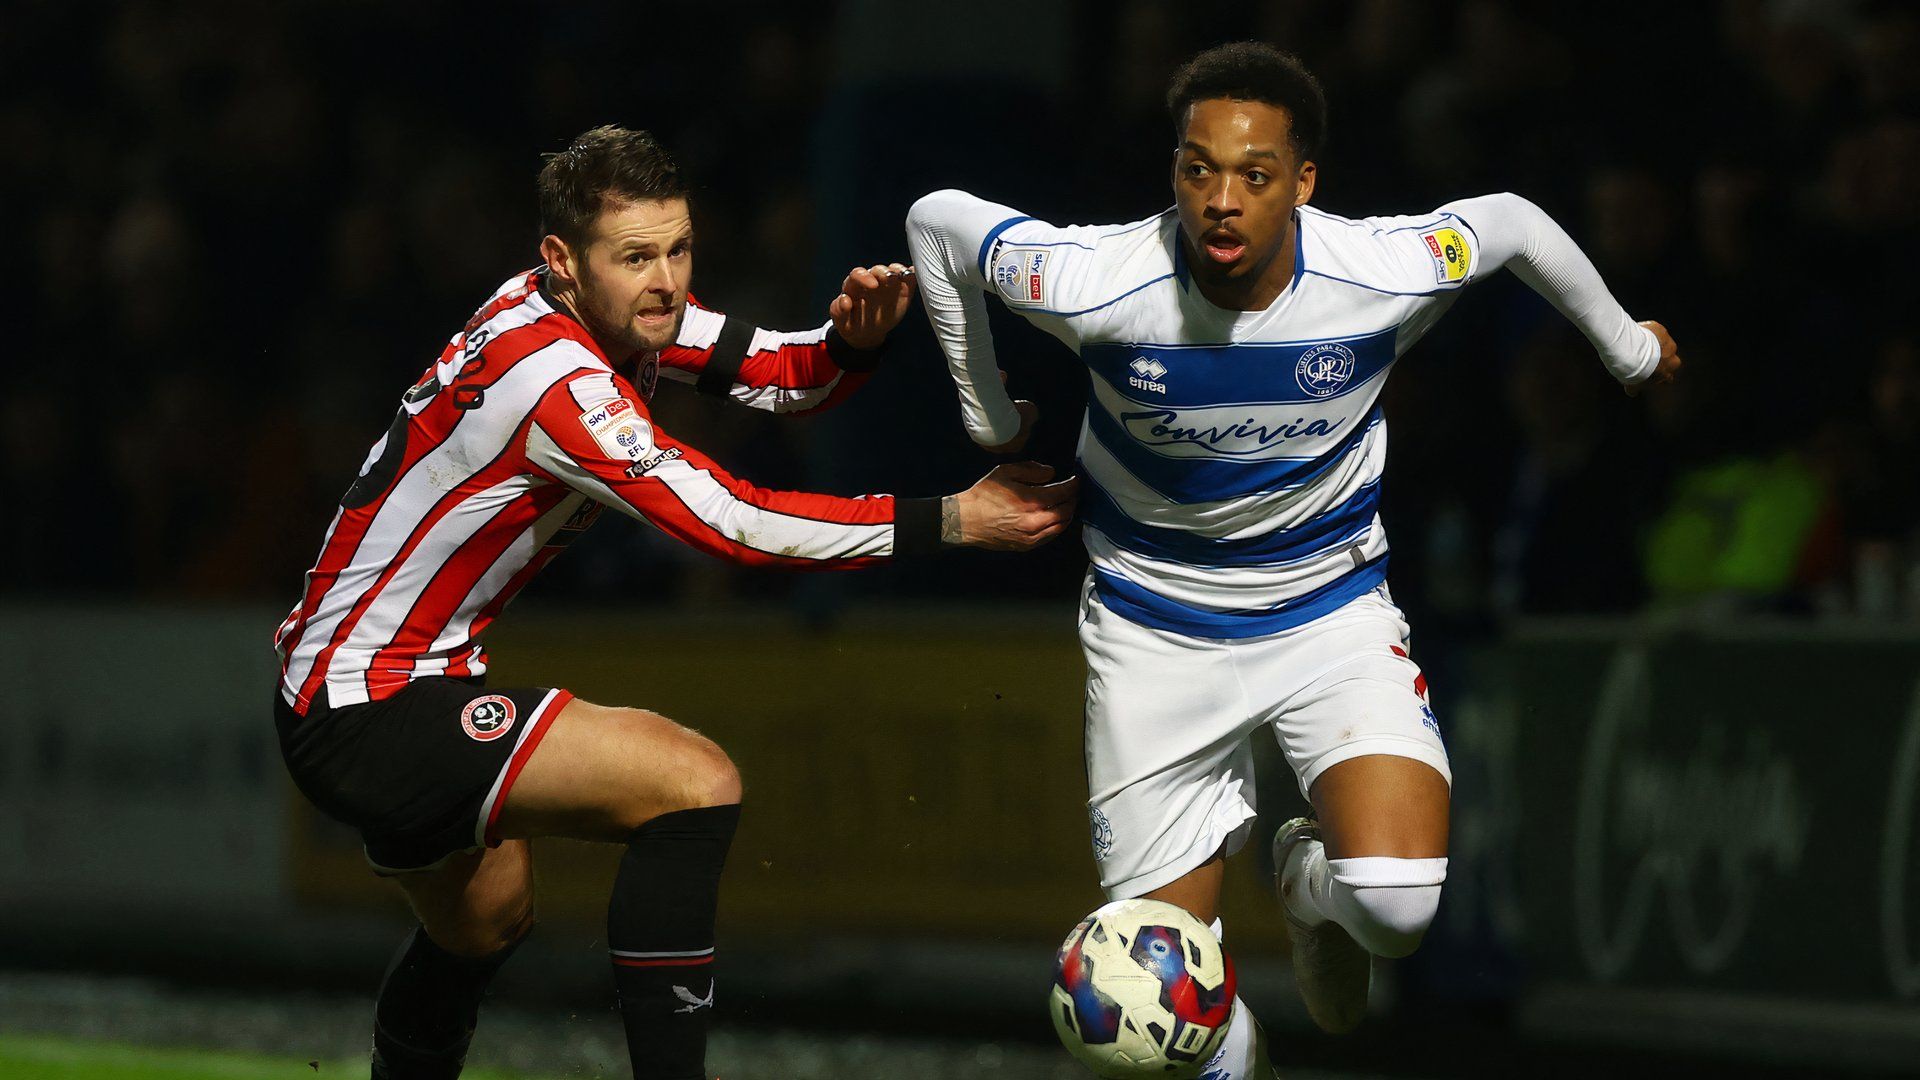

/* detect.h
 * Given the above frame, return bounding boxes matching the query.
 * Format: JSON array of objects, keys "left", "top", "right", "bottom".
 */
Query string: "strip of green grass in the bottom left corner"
[{"left": 0, "top": 1036, "right": 576, "bottom": 1080}]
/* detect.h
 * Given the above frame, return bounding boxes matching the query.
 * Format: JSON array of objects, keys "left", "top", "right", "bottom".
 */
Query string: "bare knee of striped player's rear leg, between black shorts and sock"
[{"left": 392, "top": 840, "right": 534, "bottom": 957}]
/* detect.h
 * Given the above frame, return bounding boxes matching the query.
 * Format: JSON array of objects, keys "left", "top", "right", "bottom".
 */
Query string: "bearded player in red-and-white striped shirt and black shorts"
[{"left": 275, "top": 127, "right": 1075, "bottom": 1080}]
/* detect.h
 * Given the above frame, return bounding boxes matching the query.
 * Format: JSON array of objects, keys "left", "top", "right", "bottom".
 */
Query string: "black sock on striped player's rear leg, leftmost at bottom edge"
[{"left": 372, "top": 914, "right": 518, "bottom": 1080}]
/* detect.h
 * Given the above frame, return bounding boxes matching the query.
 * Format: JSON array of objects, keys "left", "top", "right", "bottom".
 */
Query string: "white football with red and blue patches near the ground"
[{"left": 1048, "top": 899, "right": 1235, "bottom": 1080}]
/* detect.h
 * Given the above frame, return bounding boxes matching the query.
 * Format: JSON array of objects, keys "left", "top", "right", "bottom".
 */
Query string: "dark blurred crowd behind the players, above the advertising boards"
[{"left": 15, "top": 0, "right": 1920, "bottom": 621}]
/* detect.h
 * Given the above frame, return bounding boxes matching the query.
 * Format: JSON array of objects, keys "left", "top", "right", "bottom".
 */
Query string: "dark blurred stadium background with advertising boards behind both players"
[{"left": 0, "top": 0, "right": 1920, "bottom": 1080}]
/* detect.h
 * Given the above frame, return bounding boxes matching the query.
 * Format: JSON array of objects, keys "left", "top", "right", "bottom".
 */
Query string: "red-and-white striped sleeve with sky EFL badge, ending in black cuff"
[{"left": 526, "top": 373, "right": 939, "bottom": 557}]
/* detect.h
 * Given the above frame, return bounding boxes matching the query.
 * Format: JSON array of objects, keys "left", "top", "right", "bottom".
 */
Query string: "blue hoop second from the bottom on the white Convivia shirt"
[{"left": 1081, "top": 480, "right": 1380, "bottom": 567}]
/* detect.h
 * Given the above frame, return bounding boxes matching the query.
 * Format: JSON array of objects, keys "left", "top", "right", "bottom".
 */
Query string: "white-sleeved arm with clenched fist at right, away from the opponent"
[{"left": 1440, "top": 192, "right": 1680, "bottom": 394}]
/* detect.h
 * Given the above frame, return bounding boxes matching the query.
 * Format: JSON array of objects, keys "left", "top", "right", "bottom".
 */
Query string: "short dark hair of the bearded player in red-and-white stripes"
[{"left": 540, "top": 123, "right": 687, "bottom": 244}]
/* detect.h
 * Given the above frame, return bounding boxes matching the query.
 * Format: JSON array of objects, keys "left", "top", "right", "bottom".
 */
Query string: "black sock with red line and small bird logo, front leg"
[{"left": 607, "top": 803, "right": 739, "bottom": 1080}]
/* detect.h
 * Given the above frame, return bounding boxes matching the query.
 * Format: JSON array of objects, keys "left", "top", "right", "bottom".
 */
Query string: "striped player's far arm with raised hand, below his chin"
[{"left": 660, "top": 263, "right": 914, "bottom": 413}]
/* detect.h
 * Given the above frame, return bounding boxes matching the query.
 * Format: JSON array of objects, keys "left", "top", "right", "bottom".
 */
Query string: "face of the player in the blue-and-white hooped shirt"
[{"left": 1173, "top": 98, "right": 1313, "bottom": 292}]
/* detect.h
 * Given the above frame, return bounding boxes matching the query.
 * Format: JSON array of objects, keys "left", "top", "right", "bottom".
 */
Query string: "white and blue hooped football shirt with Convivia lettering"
[{"left": 944, "top": 197, "right": 1478, "bottom": 638}]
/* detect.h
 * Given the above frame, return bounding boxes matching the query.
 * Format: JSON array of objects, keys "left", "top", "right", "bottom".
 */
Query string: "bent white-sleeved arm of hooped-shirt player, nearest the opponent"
[{"left": 906, "top": 190, "right": 1033, "bottom": 454}]
